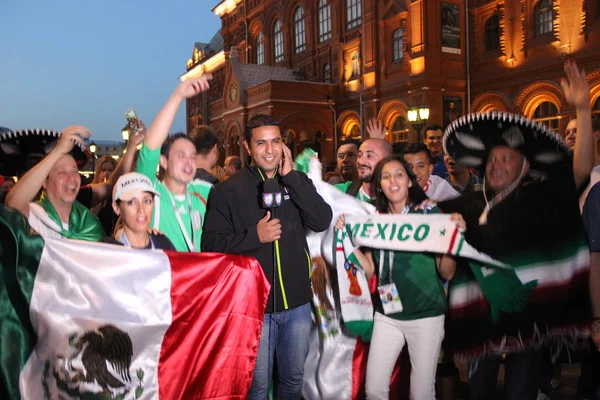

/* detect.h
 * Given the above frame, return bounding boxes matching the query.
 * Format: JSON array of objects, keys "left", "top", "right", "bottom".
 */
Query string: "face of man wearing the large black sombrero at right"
[{"left": 485, "top": 146, "right": 529, "bottom": 194}]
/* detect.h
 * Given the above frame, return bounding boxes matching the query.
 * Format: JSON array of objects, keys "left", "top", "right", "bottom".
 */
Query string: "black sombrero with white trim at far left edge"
[{"left": 0, "top": 129, "right": 89, "bottom": 176}]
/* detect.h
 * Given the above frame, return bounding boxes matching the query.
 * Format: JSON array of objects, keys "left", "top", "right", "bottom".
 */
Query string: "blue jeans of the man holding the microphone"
[{"left": 248, "top": 303, "right": 312, "bottom": 400}]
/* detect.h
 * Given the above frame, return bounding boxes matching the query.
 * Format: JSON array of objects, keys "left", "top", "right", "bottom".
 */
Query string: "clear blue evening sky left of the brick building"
[{"left": 0, "top": 0, "right": 221, "bottom": 140}]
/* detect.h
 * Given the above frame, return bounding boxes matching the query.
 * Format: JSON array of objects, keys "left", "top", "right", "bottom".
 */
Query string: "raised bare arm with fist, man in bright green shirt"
[{"left": 145, "top": 74, "right": 212, "bottom": 150}]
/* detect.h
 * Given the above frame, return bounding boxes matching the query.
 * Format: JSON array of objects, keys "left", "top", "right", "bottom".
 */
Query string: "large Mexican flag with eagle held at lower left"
[{"left": 0, "top": 206, "right": 270, "bottom": 400}]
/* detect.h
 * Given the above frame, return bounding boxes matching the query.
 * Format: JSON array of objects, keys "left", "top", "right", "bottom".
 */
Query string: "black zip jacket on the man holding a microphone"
[{"left": 202, "top": 165, "right": 332, "bottom": 313}]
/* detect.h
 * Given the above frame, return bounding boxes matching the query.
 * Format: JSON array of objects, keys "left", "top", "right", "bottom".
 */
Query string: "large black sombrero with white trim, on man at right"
[{"left": 442, "top": 111, "right": 572, "bottom": 176}]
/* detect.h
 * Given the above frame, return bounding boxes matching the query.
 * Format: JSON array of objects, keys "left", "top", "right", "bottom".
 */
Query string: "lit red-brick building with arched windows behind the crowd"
[{"left": 181, "top": 0, "right": 600, "bottom": 160}]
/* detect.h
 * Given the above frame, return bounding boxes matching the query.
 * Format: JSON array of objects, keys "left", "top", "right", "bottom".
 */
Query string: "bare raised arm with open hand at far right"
[{"left": 560, "top": 61, "right": 594, "bottom": 188}]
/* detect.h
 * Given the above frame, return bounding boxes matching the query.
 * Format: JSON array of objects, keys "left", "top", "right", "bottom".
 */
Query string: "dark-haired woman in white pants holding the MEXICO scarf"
[{"left": 336, "top": 156, "right": 466, "bottom": 400}]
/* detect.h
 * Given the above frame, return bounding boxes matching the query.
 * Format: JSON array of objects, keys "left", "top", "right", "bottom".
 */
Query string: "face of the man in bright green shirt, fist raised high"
[{"left": 160, "top": 138, "right": 196, "bottom": 185}]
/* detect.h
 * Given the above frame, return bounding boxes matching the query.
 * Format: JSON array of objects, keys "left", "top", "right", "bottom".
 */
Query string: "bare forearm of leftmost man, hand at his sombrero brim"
[{"left": 5, "top": 125, "right": 91, "bottom": 217}]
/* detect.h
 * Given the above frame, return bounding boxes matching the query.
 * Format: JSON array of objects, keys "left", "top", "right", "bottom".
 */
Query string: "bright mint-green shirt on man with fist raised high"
[{"left": 136, "top": 145, "right": 212, "bottom": 251}]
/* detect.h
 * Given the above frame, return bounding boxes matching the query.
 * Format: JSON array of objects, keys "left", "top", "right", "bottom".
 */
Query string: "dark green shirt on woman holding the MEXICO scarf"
[{"left": 373, "top": 207, "right": 447, "bottom": 320}]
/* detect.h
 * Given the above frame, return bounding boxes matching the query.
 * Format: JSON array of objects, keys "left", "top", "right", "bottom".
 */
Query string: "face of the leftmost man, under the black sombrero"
[{"left": 42, "top": 154, "right": 81, "bottom": 207}]
